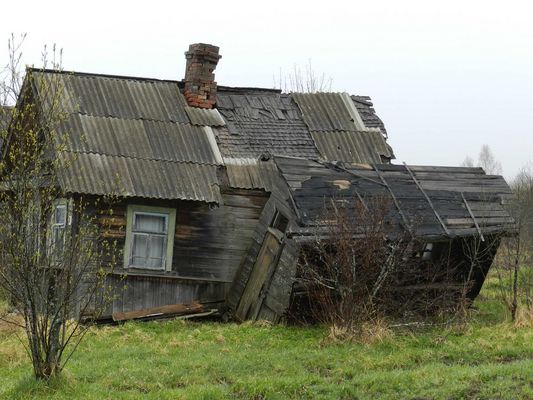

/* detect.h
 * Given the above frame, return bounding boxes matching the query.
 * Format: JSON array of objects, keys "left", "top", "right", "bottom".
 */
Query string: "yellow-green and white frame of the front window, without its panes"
[{"left": 124, "top": 204, "right": 176, "bottom": 271}]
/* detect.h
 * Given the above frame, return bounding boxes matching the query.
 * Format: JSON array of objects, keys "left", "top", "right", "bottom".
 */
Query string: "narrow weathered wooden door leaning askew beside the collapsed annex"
[{"left": 235, "top": 229, "right": 280, "bottom": 321}]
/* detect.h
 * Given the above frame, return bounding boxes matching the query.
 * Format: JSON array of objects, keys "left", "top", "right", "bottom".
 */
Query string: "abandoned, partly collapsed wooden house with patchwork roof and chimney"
[{"left": 1, "top": 44, "right": 512, "bottom": 321}]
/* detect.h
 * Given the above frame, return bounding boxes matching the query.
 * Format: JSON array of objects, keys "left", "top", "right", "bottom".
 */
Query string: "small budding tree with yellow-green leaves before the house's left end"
[{"left": 0, "top": 33, "right": 115, "bottom": 378}]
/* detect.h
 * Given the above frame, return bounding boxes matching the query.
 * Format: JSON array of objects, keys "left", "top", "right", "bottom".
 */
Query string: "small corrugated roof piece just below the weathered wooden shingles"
[{"left": 224, "top": 158, "right": 279, "bottom": 191}]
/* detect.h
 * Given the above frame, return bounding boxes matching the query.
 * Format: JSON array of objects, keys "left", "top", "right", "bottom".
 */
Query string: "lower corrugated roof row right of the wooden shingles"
[{"left": 311, "top": 130, "right": 393, "bottom": 164}]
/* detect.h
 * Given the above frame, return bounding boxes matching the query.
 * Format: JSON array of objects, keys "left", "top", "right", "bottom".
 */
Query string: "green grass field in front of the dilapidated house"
[{"left": 0, "top": 278, "right": 533, "bottom": 399}]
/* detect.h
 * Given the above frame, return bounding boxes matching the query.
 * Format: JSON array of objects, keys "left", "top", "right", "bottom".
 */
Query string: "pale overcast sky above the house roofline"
[{"left": 0, "top": 0, "right": 533, "bottom": 177}]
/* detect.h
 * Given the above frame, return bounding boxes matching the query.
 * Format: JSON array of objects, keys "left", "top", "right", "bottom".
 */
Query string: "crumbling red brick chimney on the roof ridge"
[{"left": 183, "top": 43, "right": 222, "bottom": 108}]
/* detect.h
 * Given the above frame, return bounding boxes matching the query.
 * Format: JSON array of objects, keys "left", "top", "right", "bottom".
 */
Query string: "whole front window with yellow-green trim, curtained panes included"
[{"left": 124, "top": 206, "right": 176, "bottom": 270}]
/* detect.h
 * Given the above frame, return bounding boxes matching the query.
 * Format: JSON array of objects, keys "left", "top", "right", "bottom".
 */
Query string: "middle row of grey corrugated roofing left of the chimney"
[{"left": 63, "top": 114, "right": 221, "bottom": 164}]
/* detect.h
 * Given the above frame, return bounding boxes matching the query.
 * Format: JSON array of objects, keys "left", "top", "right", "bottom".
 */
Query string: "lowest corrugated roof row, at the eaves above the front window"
[{"left": 59, "top": 152, "right": 221, "bottom": 203}]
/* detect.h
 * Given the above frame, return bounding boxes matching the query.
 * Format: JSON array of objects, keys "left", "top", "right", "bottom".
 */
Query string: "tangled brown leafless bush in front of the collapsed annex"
[{"left": 290, "top": 198, "right": 463, "bottom": 332}]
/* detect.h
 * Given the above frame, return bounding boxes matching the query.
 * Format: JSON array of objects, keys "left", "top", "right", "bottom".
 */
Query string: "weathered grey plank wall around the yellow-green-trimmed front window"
[{"left": 81, "top": 190, "right": 268, "bottom": 313}]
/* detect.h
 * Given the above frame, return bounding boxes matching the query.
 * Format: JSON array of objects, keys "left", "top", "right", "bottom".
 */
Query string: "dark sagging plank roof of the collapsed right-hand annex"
[{"left": 275, "top": 157, "right": 515, "bottom": 239}]
